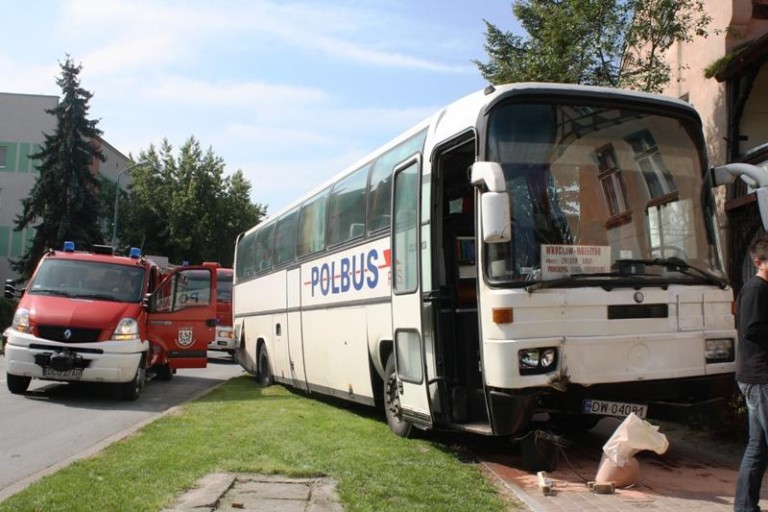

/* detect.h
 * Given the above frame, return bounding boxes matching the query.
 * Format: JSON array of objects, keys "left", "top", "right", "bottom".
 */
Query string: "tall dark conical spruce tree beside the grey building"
[{"left": 11, "top": 56, "right": 104, "bottom": 279}]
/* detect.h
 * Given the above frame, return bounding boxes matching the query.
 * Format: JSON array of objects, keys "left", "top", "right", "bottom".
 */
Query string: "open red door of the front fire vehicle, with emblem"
[{"left": 147, "top": 263, "right": 218, "bottom": 369}]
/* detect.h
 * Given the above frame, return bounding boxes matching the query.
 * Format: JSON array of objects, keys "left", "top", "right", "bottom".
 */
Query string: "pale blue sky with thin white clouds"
[{"left": 0, "top": 0, "right": 520, "bottom": 214}]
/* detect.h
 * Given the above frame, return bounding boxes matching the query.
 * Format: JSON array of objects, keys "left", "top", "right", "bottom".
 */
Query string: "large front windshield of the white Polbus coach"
[{"left": 484, "top": 98, "right": 724, "bottom": 286}]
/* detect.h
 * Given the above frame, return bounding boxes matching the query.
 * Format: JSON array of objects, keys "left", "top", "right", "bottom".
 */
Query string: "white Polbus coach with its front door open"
[{"left": 233, "top": 84, "right": 768, "bottom": 436}]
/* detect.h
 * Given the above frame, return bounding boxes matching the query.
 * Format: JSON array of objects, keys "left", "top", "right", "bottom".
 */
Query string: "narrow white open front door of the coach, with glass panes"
[{"left": 392, "top": 156, "right": 432, "bottom": 428}]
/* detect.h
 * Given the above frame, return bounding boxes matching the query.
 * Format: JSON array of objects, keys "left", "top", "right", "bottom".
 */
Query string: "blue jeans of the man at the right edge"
[{"left": 733, "top": 382, "right": 768, "bottom": 512}]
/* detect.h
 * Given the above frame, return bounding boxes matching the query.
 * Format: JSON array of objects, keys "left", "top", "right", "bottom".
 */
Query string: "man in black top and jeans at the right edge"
[{"left": 733, "top": 237, "right": 768, "bottom": 512}]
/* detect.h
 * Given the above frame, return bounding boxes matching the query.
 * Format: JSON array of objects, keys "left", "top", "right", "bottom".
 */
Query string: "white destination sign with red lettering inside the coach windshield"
[{"left": 541, "top": 244, "right": 611, "bottom": 279}]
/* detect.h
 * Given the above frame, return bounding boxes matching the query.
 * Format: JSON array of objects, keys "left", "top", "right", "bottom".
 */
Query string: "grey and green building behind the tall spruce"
[{"left": 0, "top": 93, "right": 129, "bottom": 282}]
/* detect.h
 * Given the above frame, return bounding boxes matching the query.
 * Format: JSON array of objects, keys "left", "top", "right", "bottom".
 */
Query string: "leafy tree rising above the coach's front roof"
[{"left": 475, "top": 0, "right": 711, "bottom": 92}]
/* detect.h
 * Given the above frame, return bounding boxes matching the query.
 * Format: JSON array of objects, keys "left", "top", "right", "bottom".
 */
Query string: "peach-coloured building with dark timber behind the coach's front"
[{"left": 665, "top": 0, "right": 768, "bottom": 291}]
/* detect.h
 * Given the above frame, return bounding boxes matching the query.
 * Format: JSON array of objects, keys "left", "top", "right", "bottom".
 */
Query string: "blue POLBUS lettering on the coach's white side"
[{"left": 310, "top": 249, "right": 379, "bottom": 297}]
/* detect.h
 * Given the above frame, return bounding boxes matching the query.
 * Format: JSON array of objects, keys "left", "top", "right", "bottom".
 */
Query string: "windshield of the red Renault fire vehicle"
[{"left": 29, "top": 258, "right": 144, "bottom": 302}]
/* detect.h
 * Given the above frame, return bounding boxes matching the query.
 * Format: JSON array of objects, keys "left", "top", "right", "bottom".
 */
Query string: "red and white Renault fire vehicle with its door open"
[{"left": 5, "top": 242, "right": 218, "bottom": 400}]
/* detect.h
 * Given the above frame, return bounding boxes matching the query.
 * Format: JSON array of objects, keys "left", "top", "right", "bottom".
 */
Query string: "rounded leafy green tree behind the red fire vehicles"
[{"left": 118, "top": 137, "right": 266, "bottom": 266}]
